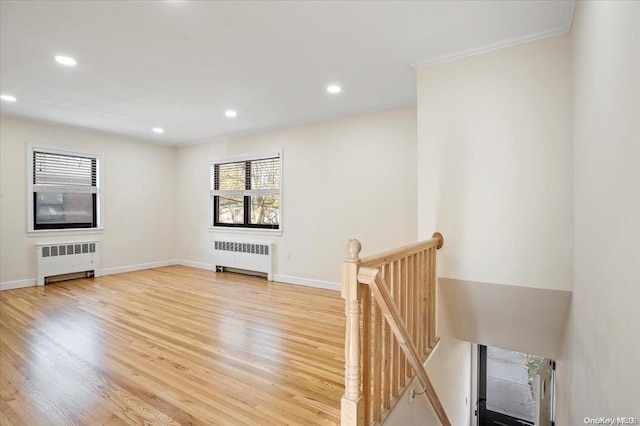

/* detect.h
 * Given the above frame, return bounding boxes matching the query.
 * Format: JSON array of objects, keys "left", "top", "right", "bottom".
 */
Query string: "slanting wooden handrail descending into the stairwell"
[{"left": 358, "top": 266, "right": 451, "bottom": 426}]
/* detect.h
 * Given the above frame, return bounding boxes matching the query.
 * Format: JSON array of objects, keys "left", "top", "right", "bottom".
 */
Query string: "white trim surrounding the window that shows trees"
[{"left": 207, "top": 148, "right": 284, "bottom": 236}]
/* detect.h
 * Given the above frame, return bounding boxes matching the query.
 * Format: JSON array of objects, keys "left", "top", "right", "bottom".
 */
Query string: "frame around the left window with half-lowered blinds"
[{"left": 27, "top": 145, "right": 104, "bottom": 236}]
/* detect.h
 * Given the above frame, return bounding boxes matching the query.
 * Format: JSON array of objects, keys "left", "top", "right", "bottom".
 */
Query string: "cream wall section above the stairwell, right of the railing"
[{"left": 417, "top": 35, "right": 573, "bottom": 290}]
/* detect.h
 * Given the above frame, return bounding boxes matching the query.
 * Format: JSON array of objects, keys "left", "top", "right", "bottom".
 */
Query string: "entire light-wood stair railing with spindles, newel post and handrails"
[{"left": 341, "top": 233, "right": 450, "bottom": 426}]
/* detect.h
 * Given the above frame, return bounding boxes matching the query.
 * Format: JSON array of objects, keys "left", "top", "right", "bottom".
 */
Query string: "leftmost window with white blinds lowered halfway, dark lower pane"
[{"left": 31, "top": 148, "right": 99, "bottom": 230}]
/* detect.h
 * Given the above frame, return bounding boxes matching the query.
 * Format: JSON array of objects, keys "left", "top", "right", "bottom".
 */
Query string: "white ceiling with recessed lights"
[{"left": 0, "top": 0, "right": 575, "bottom": 145}]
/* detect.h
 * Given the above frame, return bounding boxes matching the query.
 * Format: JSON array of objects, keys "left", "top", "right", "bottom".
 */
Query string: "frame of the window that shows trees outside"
[{"left": 209, "top": 149, "right": 283, "bottom": 234}]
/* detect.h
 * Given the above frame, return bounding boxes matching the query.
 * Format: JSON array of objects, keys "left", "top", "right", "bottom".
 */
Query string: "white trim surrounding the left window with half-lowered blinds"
[{"left": 27, "top": 145, "right": 104, "bottom": 237}]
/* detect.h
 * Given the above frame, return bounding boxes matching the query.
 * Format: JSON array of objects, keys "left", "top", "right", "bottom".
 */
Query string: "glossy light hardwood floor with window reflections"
[{"left": 0, "top": 266, "right": 345, "bottom": 426}]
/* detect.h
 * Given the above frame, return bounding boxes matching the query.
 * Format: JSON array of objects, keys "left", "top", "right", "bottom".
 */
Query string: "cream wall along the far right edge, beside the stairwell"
[{"left": 558, "top": 1, "right": 640, "bottom": 425}]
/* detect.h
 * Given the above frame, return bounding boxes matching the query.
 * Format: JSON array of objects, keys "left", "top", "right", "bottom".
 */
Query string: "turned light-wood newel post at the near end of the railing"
[{"left": 341, "top": 240, "right": 364, "bottom": 426}]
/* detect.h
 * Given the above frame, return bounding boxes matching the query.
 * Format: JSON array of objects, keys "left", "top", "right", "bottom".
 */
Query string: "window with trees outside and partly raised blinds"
[{"left": 210, "top": 151, "right": 280, "bottom": 229}]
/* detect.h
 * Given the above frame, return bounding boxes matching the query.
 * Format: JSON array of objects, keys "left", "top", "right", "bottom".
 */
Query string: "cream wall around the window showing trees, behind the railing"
[{"left": 177, "top": 108, "right": 417, "bottom": 285}]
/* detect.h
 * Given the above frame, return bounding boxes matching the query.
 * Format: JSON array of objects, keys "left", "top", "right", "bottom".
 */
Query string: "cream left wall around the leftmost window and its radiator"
[{"left": 0, "top": 118, "right": 176, "bottom": 287}]
